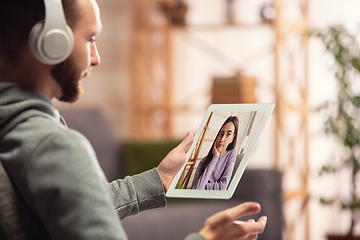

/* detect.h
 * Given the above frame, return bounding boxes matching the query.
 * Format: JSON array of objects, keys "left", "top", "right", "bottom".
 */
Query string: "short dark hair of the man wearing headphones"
[{"left": 0, "top": 0, "right": 79, "bottom": 65}]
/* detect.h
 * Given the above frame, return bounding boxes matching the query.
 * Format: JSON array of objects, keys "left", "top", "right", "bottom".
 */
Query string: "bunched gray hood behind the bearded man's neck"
[{"left": 0, "top": 83, "right": 59, "bottom": 139}]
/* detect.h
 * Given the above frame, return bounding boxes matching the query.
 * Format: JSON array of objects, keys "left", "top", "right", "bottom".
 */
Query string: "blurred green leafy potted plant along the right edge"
[{"left": 314, "top": 25, "right": 360, "bottom": 240}]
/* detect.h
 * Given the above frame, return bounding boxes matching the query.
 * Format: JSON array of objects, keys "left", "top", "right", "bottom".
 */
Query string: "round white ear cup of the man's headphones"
[{"left": 29, "top": 22, "right": 74, "bottom": 65}]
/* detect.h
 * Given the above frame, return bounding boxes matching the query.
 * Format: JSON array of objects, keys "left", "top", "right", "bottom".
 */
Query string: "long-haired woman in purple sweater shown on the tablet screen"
[{"left": 191, "top": 116, "right": 239, "bottom": 190}]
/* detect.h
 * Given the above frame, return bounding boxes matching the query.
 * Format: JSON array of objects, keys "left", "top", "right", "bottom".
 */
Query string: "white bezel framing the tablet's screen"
[{"left": 166, "top": 103, "right": 275, "bottom": 199}]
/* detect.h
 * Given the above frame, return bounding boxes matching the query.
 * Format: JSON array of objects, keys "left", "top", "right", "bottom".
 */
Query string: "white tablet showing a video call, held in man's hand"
[{"left": 166, "top": 104, "right": 275, "bottom": 199}]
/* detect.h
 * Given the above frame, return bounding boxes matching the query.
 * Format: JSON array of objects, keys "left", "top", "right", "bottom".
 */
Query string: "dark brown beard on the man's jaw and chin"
[{"left": 51, "top": 56, "right": 89, "bottom": 103}]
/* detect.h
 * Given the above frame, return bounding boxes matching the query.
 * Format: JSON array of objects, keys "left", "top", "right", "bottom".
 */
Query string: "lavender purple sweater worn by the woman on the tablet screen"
[{"left": 191, "top": 148, "right": 236, "bottom": 190}]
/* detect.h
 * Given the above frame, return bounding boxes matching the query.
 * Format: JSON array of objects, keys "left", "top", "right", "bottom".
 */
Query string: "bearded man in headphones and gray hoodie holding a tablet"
[{"left": 0, "top": 0, "right": 266, "bottom": 240}]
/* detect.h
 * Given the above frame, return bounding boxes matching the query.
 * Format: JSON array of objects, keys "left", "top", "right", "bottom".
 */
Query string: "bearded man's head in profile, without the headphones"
[{"left": 0, "top": 0, "right": 101, "bottom": 102}]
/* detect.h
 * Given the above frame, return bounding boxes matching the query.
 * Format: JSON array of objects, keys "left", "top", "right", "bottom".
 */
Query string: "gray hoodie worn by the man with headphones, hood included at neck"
[{"left": 0, "top": 83, "right": 167, "bottom": 240}]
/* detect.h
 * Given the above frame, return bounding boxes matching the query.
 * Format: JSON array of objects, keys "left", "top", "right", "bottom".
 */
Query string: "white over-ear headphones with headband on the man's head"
[{"left": 29, "top": 0, "right": 74, "bottom": 65}]
